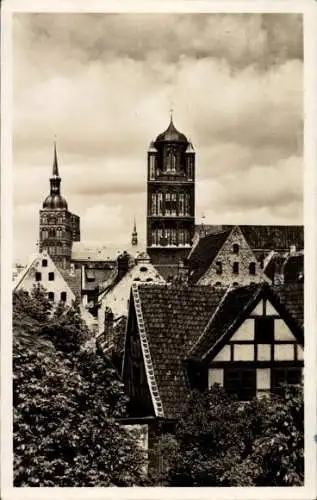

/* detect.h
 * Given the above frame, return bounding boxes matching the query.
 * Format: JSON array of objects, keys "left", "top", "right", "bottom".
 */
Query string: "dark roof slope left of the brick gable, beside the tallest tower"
[{"left": 189, "top": 226, "right": 233, "bottom": 283}]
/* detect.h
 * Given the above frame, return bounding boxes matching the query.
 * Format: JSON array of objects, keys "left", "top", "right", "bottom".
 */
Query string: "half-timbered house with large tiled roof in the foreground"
[{"left": 122, "top": 283, "right": 304, "bottom": 423}]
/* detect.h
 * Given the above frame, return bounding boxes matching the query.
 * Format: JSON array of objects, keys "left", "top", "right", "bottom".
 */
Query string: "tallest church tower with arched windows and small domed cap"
[{"left": 147, "top": 116, "right": 195, "bottom": 275}]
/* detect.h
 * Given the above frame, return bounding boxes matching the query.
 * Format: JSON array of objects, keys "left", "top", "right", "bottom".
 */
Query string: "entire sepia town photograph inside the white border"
[{"left": 2, "top": 2, "right": 316, "bottom": 499}]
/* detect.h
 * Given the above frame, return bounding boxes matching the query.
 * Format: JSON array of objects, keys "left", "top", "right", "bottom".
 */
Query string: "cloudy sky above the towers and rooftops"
[{"left": 13, "top": 14, "right": 303, "bottom": 261}]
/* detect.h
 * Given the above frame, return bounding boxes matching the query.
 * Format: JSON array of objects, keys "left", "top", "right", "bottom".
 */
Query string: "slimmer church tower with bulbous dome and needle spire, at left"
[{"left": 39, "top": 143, "right": 80, "bottom": 269}]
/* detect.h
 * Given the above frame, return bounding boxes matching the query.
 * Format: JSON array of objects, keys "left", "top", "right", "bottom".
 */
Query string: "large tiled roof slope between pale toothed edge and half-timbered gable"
[{"left": 132, "top": 284, "right": 226, "bottom": 418}]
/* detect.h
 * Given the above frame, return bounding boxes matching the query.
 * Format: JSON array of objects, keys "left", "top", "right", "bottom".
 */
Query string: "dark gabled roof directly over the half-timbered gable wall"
[{"left": 189, "top": 283, "right": 304, "bottom": 361}]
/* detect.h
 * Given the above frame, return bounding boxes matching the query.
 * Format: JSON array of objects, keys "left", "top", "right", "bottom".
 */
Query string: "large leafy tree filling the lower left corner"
[{"left": 13, "top": 288, "right": 144, "bottom": 486}]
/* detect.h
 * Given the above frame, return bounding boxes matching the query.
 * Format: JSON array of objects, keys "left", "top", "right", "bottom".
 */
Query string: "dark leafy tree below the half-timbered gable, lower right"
[{"left": 152, "top": 386, "right": 304, "bottom": 486}]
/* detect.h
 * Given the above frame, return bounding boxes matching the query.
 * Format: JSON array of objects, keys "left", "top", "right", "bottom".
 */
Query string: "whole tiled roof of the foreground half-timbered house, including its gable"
[{"left": 133, "top": 283, "right": 304, "bottom": 418}]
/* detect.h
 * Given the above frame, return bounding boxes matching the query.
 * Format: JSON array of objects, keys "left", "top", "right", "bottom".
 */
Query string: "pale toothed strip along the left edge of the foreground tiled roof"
[{"left": 132, "top": 283, "right": 164, "bottom": 417}]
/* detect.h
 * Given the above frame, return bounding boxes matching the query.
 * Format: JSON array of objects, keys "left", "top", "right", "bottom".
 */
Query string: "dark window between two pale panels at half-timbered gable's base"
[{"left": 224, "top": 368, "right": 256, "bottom": 401}]
